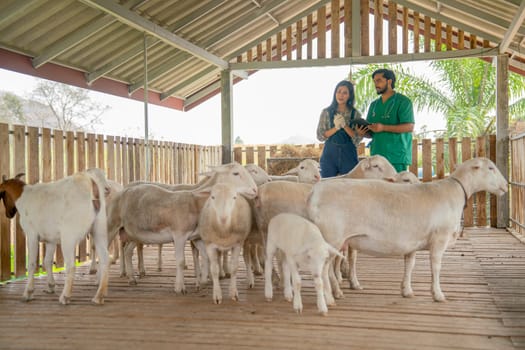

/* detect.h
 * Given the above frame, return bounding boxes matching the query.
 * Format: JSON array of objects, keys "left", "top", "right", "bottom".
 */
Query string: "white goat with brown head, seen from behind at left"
[{"left": 0, "top": 172, "right": 109, "bottom": 305}]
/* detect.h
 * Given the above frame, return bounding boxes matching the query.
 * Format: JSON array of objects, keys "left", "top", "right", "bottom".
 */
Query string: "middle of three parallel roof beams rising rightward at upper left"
[{"left": 86, "top": 0, "right": 226, "bottom": 84}]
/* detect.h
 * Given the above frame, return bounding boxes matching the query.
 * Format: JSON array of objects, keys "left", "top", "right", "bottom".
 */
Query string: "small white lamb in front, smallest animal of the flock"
[{"left": 264, "top": 213, "right": 343, "bottom": 316}]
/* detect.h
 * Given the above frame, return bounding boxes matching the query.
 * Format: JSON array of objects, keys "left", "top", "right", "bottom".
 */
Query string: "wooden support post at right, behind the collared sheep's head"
[{"left": 496, "top": 54, "right": 509, "bottom": 228}]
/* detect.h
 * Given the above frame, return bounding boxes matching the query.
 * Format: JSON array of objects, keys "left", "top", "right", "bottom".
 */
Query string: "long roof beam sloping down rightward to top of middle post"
[{"left": 81, "top": 0, "right": 228, "bottom": 69}]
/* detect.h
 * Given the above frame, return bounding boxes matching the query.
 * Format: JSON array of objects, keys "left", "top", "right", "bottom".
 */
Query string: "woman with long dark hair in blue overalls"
[{"left": 317, "top": 80, "right": 366, "bottom": 177}]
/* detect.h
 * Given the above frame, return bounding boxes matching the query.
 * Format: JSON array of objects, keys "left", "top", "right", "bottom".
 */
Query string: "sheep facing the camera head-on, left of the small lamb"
[{"left": 198, "top": 183, "right": 253, "bottom": 304}]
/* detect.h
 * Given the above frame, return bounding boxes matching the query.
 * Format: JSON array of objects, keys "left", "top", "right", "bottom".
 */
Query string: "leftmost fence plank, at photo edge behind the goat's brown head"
[{"left": 0, "top": 123, "right": 11, "bottom": 281}]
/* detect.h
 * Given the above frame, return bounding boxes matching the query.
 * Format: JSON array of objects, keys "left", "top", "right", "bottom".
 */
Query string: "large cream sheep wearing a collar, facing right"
[{"left": 307, "top": 158, "right": 508, "bottom": 302}]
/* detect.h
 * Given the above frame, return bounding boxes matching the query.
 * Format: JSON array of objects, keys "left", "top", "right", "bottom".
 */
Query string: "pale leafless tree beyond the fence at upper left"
[{"left": 32, "top": 80, "right": 110, "bottom": 131}]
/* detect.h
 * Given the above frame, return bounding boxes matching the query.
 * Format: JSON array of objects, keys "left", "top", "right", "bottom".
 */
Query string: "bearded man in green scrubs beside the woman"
[{"left": 366, "top": 69, "right": 414, "bottom": 172}]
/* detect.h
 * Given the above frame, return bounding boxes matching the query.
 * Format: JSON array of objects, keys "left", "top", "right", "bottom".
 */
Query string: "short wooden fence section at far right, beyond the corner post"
[{"left": 509, "top": 133, "right": 525, "bottom": 242}]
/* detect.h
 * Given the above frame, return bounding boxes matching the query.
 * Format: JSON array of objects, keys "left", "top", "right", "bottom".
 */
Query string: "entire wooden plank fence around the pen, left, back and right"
[{"left": 0, "top": 124, "right": 524, "bottom": 281}]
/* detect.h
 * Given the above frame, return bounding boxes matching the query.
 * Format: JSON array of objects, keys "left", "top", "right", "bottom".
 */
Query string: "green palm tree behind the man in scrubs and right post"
[{"left": 352, "top": 58, "right": 525, "bottom": 137}]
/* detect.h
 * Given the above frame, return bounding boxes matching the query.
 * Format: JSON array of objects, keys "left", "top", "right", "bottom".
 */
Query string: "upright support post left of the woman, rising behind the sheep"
[{"left": 221, "top": 70, "right": 233, "bottom": 164}]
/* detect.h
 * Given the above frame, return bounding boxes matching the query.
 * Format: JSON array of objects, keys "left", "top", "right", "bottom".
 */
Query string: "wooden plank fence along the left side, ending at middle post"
[{"left": 0, "top": 124, "right": 222, "bottom": 281}]
